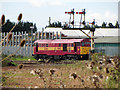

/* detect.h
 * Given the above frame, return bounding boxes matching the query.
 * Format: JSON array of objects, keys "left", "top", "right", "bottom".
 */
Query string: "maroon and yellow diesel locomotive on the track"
[{"left": 33, "top": 39, "right": 91, "bottom": 60}]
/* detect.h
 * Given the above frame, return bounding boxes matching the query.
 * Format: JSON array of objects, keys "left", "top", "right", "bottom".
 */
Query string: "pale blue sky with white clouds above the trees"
[{"left": 0, "top": 0, "right": 119, "bottom": 30}]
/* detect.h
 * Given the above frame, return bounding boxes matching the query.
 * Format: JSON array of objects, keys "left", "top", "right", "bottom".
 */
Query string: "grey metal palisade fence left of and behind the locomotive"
[{"left": 0, "top": 31, "right": 61, "bottom": 56}]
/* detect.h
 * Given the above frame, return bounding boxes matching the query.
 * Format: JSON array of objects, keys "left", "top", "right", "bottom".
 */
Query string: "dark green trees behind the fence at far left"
[{"left": 2, "top": 19, "right": 37, "bottom": 33}]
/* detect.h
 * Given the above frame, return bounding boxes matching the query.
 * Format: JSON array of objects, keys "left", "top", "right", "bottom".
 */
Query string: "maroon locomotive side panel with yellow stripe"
[{"left": 34, "top": 43, "right": 74, "bottom": 55}]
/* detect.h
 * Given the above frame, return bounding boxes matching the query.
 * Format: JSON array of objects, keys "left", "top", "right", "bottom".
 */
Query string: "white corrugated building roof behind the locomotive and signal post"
[{"left": 44, "top": 28, "right": 120, "bottom": 37}]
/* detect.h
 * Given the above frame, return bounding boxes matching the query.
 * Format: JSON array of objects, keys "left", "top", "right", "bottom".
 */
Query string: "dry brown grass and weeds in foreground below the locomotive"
[{"left": 2, "top": 53, "right": 120, "bottom": 88}]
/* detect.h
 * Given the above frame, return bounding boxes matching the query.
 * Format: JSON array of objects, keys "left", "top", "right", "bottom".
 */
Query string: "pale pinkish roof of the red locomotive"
[{"left": 35, "top": 39, "right": 88, "bottom": 43}]
